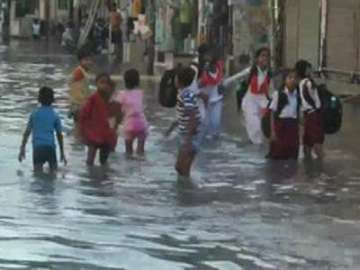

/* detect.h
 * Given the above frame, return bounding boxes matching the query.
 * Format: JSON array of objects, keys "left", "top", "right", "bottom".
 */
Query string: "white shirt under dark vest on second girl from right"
[{"left": 270, "top": 88, "right": 298, "bottom": 119}]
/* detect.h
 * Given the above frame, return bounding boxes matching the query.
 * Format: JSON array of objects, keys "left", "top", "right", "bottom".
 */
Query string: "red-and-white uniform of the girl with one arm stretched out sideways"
[{"left": 242, "top": 67, "right": 272, "bottom": 144}]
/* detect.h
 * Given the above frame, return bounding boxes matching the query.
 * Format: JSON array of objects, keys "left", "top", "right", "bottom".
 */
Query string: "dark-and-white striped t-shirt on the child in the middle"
[{"left": 176, "top": 88, "right": 201, "bottom": 135}]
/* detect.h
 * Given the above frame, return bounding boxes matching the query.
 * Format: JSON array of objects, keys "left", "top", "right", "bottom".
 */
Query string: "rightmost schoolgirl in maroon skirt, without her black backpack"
[{"left": 295, "top": 60, "right": 325, "bottom": 160}]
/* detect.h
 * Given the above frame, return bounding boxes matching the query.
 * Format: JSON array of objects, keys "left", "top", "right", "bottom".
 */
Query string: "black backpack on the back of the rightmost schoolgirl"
[{"left": 317, "top": 84, "right": 343, "bottom": 134}]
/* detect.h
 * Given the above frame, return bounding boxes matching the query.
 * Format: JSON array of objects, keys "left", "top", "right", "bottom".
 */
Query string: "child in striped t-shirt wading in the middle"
[{"left": 175, "top": 67, "right": 200, "bottom": 178}]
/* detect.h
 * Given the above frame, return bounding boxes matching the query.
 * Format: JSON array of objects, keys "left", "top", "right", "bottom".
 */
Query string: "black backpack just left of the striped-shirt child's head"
[{"left": 159, "top": 68, "right": 178, "bottom": 108}]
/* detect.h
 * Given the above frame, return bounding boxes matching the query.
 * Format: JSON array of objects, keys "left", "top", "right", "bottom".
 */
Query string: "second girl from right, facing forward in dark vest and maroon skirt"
[{"left": 268, "top": 70, "right": 300, "bottom": 160}]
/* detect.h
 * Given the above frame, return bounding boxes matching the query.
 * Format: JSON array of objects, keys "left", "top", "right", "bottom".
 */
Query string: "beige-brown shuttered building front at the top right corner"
[{"left": 282, "top": 0, "right": 360, "bottom": 74}]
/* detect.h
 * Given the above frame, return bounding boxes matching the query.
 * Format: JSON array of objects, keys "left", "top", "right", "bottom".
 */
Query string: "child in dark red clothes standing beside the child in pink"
[{"left": 80, "top": 73, "right": 117, "bottom": 166}]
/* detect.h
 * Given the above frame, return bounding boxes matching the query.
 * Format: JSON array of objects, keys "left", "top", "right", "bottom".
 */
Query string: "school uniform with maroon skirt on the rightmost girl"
[{"left": 299, "top": 78, "right": 325, "bottom": 147}]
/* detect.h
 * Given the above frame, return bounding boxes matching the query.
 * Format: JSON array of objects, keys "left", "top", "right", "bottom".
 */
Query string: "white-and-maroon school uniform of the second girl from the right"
[{"left": 269, "top": 88, "right": 299, "bottom": 159}]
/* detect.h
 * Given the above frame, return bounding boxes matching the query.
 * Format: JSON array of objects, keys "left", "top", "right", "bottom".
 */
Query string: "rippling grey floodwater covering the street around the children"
[{"left": 0, "top": 40, "right": 360, "bottom": 270}]
